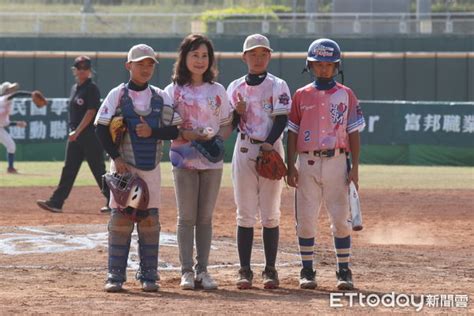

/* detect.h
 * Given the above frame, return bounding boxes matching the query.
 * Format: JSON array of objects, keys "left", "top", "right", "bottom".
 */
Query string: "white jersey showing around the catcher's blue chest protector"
[{"left": 94, "top": 83, "right": 182, "bottom": 126}]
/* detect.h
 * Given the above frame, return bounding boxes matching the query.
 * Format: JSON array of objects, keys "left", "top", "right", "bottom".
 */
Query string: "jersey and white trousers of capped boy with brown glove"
[{"left": 227, "top": 73, "right": 291, "bottom": 228}]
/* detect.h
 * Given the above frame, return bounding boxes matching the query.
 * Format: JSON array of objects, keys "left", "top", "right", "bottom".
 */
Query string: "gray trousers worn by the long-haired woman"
[{"left": 173, "top": 168, "right": 222, "bottom": 273}]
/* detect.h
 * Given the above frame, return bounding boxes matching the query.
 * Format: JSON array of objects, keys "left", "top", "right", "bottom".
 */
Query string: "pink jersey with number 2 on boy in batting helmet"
[{"left": 288, "top": 83, "right": 365, "bottom": 152}]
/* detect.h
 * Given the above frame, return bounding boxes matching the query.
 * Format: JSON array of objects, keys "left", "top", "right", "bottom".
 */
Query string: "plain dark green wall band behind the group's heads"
[{"left": 0, "top": 51, "right": 474, "bottom": 101}]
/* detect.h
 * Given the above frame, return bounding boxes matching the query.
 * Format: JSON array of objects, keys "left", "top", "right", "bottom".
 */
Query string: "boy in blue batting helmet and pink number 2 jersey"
[{"left": 287, "top": 38, "right": 365, "bottom": 290}]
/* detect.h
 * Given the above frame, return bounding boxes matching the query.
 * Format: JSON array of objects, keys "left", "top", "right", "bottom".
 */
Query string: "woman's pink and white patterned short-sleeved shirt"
[{"left": 165, "top": 82, "right": 232, "bottom": 169}]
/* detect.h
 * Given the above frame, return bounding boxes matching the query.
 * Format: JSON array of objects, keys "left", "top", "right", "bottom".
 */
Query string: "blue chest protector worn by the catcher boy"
[{"left": 119, "top": 87, "right": 163, "bottom": 170}]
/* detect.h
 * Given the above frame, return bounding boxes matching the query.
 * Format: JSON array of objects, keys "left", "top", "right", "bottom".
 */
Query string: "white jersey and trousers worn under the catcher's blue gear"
[{"left": 94, "top": 83, "right": 181, "bottom": 208}]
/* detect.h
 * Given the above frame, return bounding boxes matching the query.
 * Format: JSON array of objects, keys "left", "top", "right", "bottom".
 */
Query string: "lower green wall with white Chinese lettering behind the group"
[{"left": 0, "top": 99, "right": 474, "bottom": 166}]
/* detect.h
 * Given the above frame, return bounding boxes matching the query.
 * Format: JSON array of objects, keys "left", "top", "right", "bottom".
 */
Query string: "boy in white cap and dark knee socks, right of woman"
[{"left": 227, "top": 34, "right": 291, "bottom": 289}]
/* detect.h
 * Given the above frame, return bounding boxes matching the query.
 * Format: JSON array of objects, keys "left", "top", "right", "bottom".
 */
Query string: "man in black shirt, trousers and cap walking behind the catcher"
[{"left": 36, "top": 56, "right": 110, "bottom": 213}]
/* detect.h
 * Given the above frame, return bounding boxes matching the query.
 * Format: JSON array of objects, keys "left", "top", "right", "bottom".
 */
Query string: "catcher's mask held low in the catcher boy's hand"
[{"left": 104, "top": 173, "right": 150, "bottom": 211}]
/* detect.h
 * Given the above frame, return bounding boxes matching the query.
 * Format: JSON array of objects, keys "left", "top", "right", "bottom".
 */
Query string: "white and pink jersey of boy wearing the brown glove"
[{"left": 227, "top": 73, "right": 291, "bottom": 141}]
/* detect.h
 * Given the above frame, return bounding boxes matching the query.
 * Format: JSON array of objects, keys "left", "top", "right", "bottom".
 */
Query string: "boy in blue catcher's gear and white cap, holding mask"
[{"left": 95, "top": 44, "right": 181, "bottom": 292}]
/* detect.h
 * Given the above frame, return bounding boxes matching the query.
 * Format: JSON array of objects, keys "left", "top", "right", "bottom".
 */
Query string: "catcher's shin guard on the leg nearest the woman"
[{"left": 136, "top": 209, "right": 161, "bottom": 281}]
